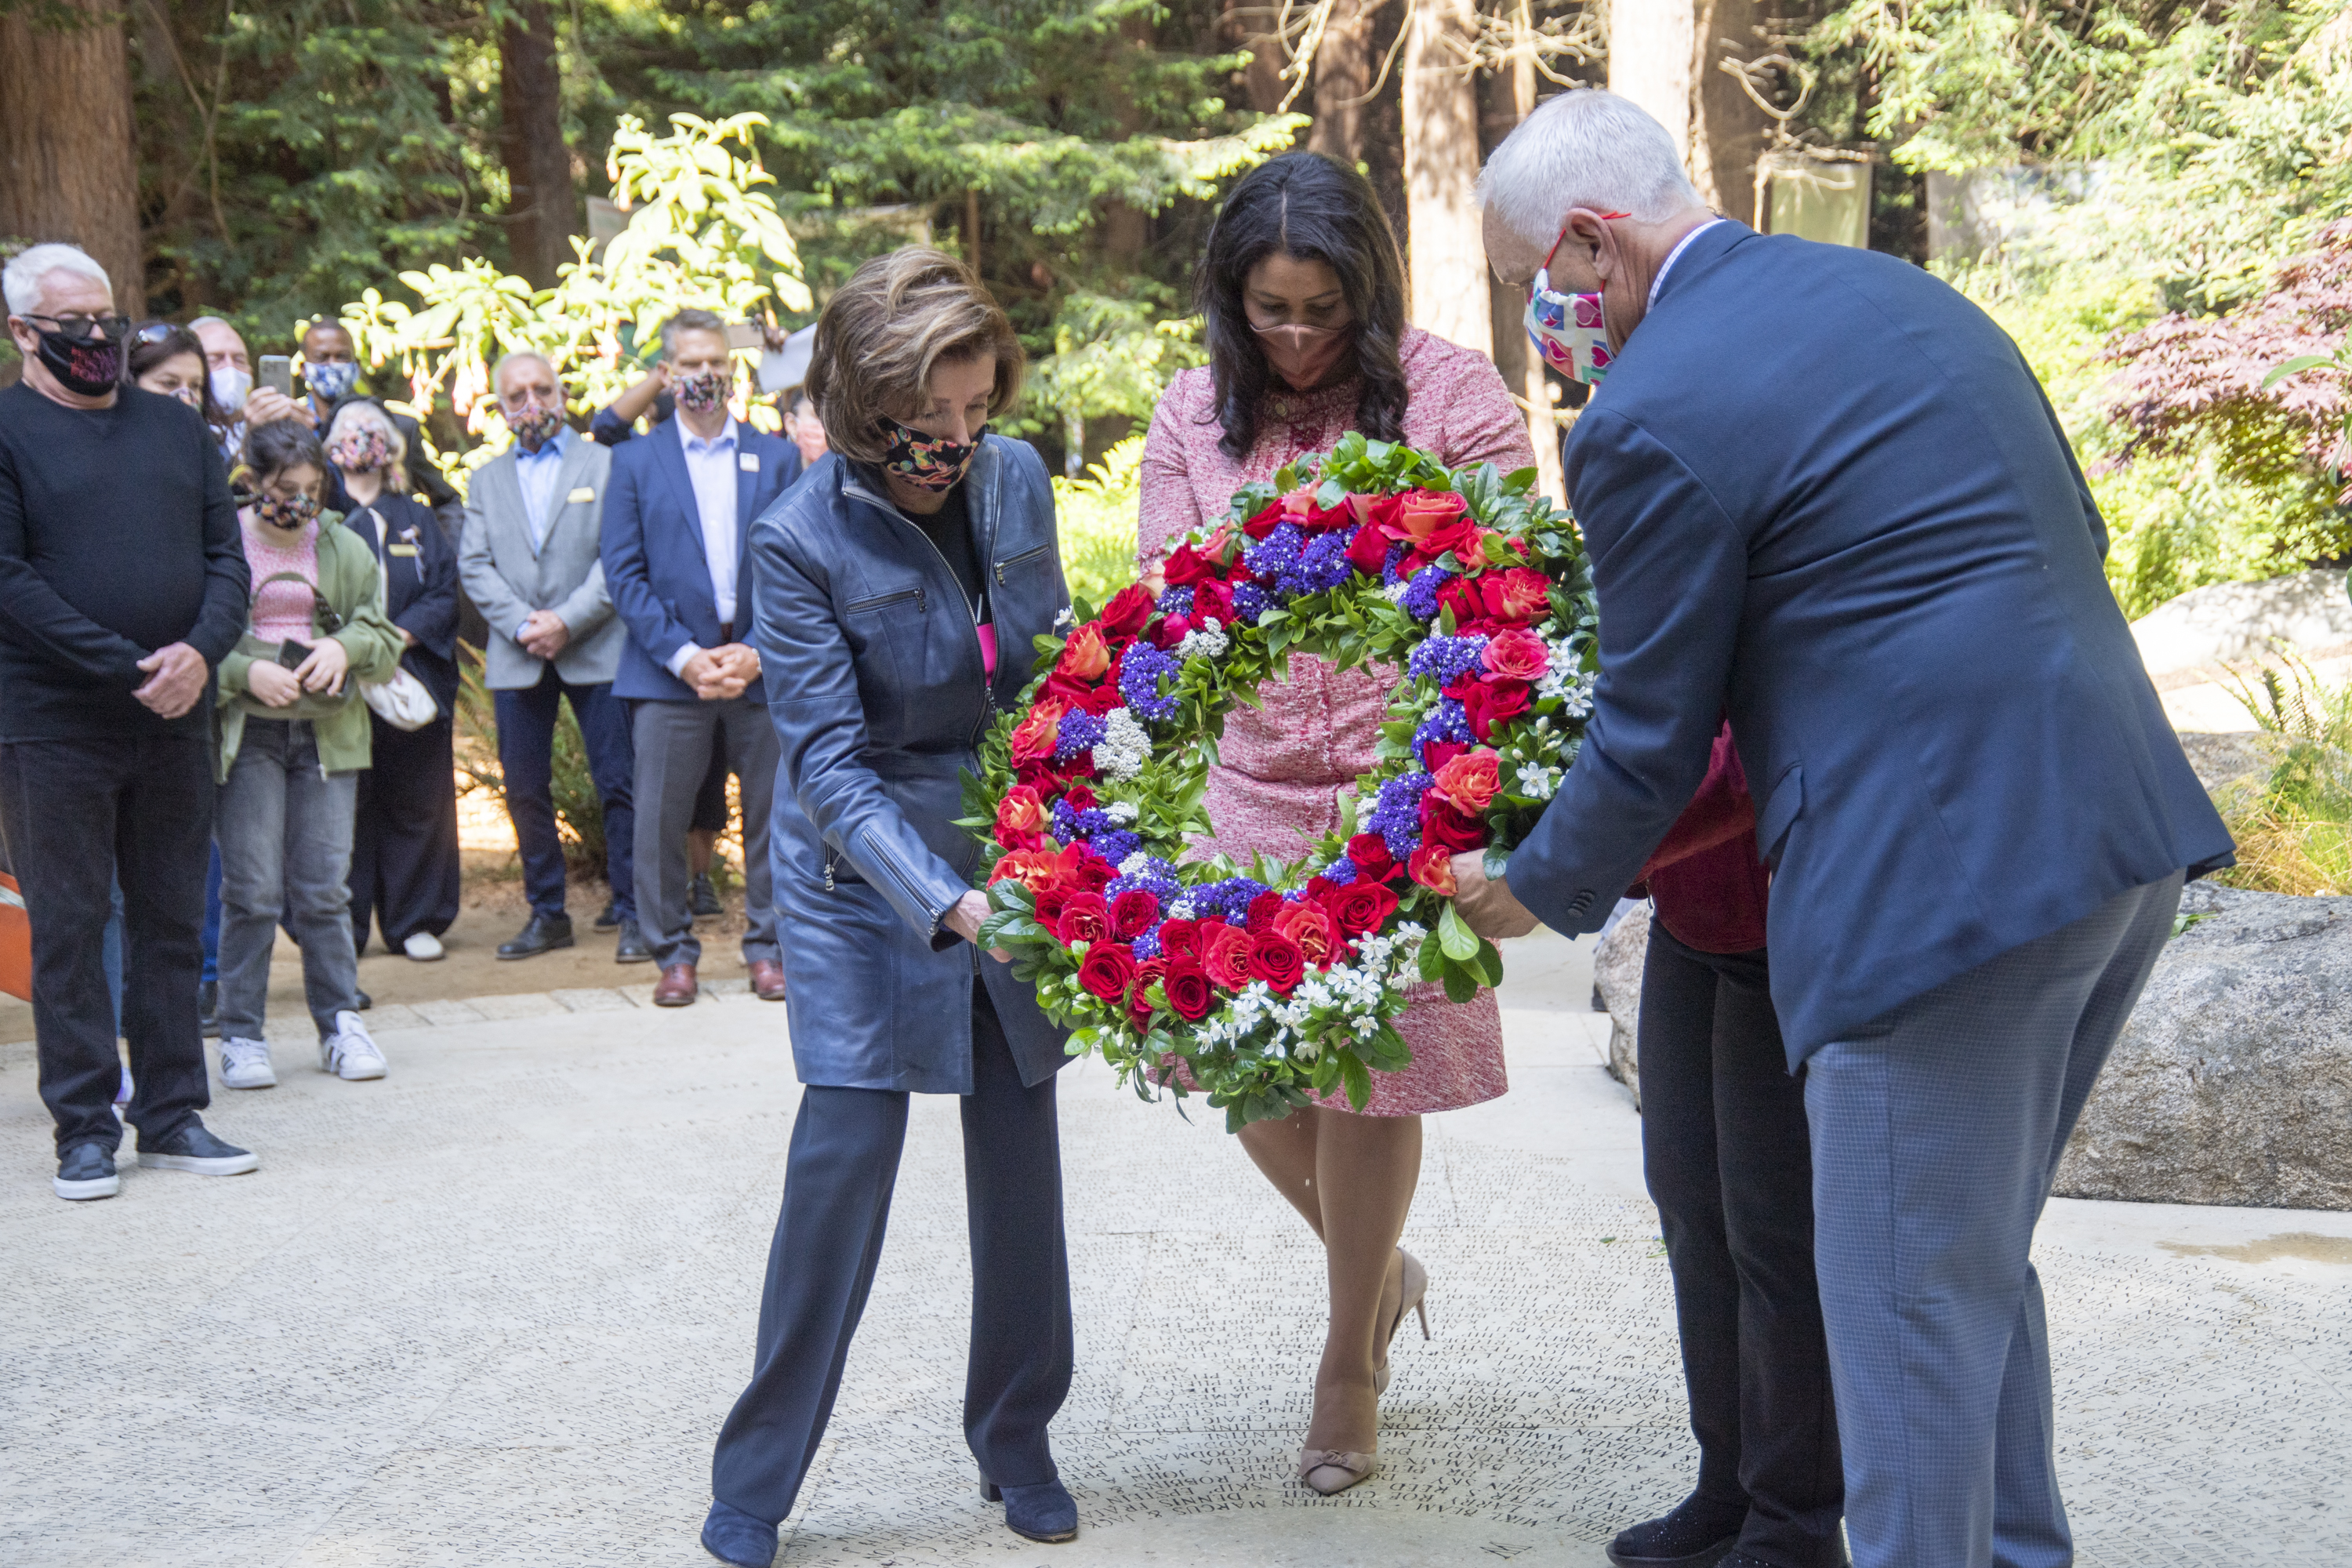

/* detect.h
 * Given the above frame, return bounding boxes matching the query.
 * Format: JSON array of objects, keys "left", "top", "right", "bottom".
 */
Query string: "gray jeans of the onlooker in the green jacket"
[{"left": 214, "top": 717, "right": 360, "bottom": 1039}]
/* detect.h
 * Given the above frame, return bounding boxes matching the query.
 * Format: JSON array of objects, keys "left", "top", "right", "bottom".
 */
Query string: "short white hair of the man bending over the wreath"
[{"left": 1477, "top": 87, "right": 1703, "bottom": 245}]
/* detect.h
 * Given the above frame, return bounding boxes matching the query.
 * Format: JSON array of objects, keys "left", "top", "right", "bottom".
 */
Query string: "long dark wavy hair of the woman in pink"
[{"left": 1195, "top": 153, "right": 1404, "bottom": 463}]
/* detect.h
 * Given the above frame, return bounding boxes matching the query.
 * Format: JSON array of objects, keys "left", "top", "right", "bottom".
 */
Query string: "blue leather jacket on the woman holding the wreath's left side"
[{"left": 748, "top": 435, "right": 1070, "bottom": 1095}]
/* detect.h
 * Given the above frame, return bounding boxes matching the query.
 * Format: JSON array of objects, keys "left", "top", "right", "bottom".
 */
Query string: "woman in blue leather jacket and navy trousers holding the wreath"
[{"left": 703, "top": 247, "right": 1077, "bottom": 1568}]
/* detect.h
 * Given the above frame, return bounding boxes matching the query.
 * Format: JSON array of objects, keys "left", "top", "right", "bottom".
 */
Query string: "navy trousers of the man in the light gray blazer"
[{"left": 492, "top": 666, "right": 637, "bottom": 919}]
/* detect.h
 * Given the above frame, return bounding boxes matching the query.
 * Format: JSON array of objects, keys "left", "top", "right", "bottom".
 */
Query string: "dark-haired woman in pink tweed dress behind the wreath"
[{"left": 1138, "top": 153, "right": 1536, "bottom": 1493}]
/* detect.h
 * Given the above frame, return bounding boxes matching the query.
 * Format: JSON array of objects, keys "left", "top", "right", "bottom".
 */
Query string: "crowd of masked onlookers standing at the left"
[{"left": 0, "top": 245, "right": 826, "bottom": 1199}]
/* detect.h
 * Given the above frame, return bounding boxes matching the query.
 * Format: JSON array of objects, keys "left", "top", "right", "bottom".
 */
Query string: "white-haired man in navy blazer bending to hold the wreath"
[{"left": 1456, "top": 92, "right": 2232, "bottom": 1568}]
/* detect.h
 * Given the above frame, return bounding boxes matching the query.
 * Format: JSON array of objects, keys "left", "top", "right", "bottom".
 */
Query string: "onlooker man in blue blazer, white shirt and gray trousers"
[{"left": 604, "top": 310, "right": 800, "bottom": 1006}]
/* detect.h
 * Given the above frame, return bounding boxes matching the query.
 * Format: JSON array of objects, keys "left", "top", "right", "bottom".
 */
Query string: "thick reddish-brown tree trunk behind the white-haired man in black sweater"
[{"left": 0, "top": 0, "right": 146, "bottom": 318}]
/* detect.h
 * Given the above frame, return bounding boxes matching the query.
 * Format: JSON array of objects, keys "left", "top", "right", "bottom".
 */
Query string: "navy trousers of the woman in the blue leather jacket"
[{"left": 710, "top": 985, "right": 1070, "bottom": 1523}]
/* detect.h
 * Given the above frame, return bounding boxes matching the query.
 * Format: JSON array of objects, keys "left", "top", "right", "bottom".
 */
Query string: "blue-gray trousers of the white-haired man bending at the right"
[{"left": 1804, "top": 872, "right": 2180, "bottom": 1568}]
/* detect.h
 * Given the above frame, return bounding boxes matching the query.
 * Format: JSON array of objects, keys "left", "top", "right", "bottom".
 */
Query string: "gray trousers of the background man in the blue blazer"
[{"left": 633, "top": 696, "right": 783, "bottom": 968}]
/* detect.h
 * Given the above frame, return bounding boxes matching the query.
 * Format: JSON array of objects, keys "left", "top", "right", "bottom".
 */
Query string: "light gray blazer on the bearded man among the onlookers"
[{"left": 456, "top": 437, "right": 628, "bottom": 691}]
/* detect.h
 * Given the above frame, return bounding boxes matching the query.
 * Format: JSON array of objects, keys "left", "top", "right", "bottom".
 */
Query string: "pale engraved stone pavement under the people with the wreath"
[{"left": 0, "top": 940, "right": 2352, "bottom": 1568}]
